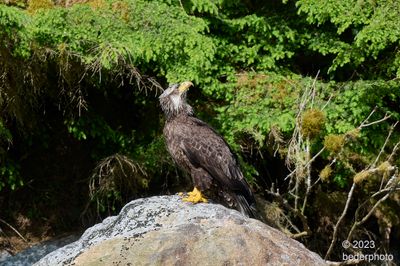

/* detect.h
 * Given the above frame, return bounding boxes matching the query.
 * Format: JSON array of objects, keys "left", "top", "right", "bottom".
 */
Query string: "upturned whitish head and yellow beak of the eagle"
[{"left": 159, "top": 81, "right": 193, "bottom": 119}]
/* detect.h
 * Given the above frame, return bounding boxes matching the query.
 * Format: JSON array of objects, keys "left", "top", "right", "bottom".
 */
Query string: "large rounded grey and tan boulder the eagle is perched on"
[{"left": 35, "top": 196, "right": 325, "bottom": 266}]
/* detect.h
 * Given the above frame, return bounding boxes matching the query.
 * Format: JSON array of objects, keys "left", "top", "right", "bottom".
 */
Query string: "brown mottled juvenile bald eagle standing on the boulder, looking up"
[{"left": 160, "top": 81, "right": 256, "bottom": 217}]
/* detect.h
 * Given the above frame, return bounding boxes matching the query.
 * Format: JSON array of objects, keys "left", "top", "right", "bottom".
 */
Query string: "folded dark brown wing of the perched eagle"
[{"left": 180, "top": 117, "right": 254, "bottom": 204}]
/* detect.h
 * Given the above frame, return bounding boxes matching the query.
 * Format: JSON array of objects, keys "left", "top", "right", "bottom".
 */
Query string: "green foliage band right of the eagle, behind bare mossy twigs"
[{"left": 219, "top": 73, "right": 400, "bottom": 151}]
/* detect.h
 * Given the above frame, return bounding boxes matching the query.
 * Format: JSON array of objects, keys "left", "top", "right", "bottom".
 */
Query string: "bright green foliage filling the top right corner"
[{"left": 296, "top": 0, "right": 400, "bottom": 77}]
